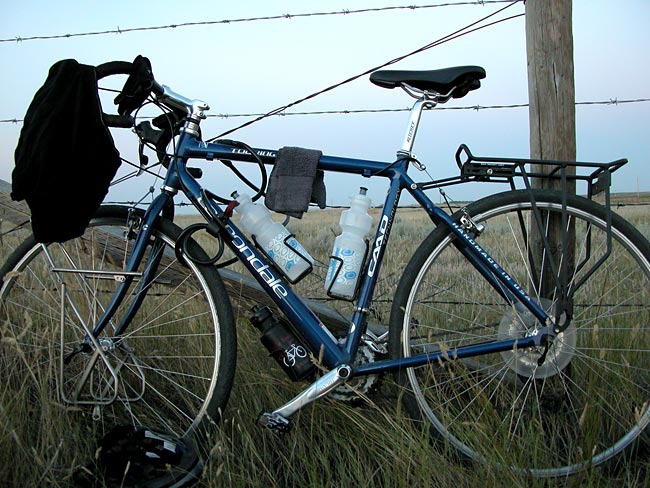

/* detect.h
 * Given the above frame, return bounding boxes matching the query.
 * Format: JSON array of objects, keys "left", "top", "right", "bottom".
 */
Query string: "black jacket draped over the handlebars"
[{"left": 11, "top": 59, "right": 120, "bottom": 242}]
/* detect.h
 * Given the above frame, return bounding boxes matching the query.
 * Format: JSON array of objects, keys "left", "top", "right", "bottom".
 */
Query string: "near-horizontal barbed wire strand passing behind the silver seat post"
[{"left": 0, "top": 98, "right": 650, "bottom": 124}]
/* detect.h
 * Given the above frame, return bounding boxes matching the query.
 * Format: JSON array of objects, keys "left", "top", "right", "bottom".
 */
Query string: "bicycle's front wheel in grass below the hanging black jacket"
[{"left": 0, "top": 206, "right": 236, "bottom": 486}]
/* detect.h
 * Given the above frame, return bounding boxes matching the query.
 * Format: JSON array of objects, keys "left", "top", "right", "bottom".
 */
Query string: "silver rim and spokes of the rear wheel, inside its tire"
[{"left": 401, "top": 197, "right": 650, "bottom": 476}]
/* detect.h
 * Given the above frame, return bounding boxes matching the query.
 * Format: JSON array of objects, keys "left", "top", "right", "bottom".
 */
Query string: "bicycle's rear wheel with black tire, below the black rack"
[{"left": 390, "top": 191, "right": 650, "bottom": 477}]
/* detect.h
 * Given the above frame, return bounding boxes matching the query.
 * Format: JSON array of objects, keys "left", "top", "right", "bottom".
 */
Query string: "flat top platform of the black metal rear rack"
[{"left": 418, "top": 144, "right": 627, "bottom": 199}]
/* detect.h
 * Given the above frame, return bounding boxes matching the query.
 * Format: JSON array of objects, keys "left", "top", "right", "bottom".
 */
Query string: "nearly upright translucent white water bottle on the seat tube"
[{"left": 325, "top": 188, "right": 372, "bottom": 299}]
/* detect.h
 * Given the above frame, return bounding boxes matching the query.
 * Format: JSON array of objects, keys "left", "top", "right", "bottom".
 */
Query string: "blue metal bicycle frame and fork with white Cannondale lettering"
[{"left": 88, "top": 133, "right": 554, "bottom": 382}]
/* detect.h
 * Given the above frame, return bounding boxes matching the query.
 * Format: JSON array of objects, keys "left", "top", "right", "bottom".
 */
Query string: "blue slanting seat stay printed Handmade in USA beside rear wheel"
[{"left": 406, "top": 176, "right": 552, "bottom": 326}]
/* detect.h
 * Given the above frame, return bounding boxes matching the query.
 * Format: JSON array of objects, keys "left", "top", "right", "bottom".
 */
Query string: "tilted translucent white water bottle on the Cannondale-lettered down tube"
[{"left": 232, "top": 192, "right": 314, "bottom": 283}]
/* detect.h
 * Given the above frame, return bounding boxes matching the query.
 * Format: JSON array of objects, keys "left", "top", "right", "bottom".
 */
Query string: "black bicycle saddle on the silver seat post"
[{"left": 370, "top": 66, "right": 485, "bottom": 98}]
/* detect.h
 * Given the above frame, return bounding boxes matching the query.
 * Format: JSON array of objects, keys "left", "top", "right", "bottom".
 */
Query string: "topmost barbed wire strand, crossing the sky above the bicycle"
[{"left": 0, "top": 0, "right": 524, "bottom": 43}]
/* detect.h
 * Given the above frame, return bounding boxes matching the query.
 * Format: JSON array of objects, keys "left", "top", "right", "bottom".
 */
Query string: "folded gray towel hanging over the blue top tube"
[{"left": 266, "top": 147, "right": 325, "bottom": 218}]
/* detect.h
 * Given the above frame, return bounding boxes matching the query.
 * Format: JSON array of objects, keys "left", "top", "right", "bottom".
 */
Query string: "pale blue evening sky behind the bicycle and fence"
[{"left": 0, "top": 0, "right": 650, "bottom": 205}]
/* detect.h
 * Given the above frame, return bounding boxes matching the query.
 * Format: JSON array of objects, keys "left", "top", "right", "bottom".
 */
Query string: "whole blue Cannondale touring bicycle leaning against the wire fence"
[{"left": 0, "top": 62, "right": 650, "bottom": 477}]
